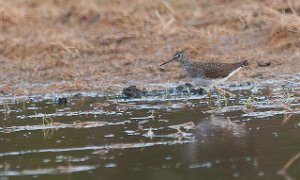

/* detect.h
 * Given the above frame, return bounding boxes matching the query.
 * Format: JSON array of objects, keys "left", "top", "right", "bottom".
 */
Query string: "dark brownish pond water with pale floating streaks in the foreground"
[{"left": 0, "top": 81, "right": 300, "bottom": 180}]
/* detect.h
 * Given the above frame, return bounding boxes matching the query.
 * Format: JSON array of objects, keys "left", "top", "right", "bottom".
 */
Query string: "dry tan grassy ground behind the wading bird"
[{"left": 0, "top": 0, "right": 300, "bottom": 95}]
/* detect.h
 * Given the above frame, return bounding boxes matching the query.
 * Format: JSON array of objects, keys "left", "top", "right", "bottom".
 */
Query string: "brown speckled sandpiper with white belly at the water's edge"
[{"left": 160, "top": 51, "right": 248, "bottom": 95}]
